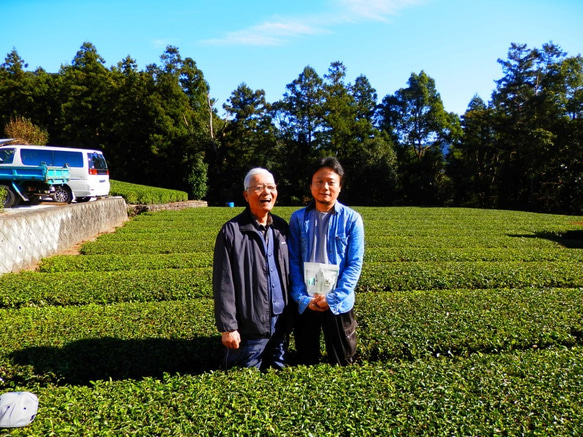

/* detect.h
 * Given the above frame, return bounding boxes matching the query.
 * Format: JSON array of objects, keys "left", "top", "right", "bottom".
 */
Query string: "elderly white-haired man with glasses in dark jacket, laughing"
[{"left": 213, "top": 168, "right": 289, "bottom": 369}]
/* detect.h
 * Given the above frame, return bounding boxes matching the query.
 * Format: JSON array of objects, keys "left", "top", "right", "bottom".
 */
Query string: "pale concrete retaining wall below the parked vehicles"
[{"left": 0, "top": 197, "right": 128, "bottom": 274}]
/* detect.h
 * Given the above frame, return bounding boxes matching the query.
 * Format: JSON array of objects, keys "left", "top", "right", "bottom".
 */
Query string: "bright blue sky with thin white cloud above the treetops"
[{"left": 0, "top": 0, "right": 583, "bottom": 115}]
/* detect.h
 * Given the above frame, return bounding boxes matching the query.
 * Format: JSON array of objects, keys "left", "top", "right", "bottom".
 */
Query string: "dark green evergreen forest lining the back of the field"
[{"left": 0, "top": 42, "right": 583, "bottom": 214}]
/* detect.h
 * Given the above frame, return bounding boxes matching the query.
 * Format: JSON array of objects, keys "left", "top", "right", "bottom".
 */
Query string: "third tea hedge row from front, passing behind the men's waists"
[{"left": 0, "top": 262, "right": 583, "bottom": 308}]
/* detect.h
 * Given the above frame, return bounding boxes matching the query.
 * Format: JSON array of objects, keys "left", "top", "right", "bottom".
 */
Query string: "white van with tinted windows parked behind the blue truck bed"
[{"left": 0, "top": 143, "right": 110, "bottom": 203}]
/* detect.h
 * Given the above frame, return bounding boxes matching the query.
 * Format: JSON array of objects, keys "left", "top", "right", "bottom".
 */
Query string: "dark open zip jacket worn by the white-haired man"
[{"left": 213, "top": 207, "right": 290, "bottom": 338}]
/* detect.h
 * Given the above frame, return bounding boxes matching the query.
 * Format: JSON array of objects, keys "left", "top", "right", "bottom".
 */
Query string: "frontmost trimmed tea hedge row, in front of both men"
[{"left": 5, "top": 347, "right": 583, "bottom": 437}]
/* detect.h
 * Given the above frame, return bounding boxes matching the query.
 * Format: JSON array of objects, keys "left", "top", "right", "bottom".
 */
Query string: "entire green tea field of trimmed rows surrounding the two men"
[{"left": 0, "top": 207, "right": 583, "bottom": 436}]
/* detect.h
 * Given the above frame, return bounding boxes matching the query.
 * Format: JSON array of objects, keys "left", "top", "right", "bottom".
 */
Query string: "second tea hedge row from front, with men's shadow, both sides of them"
[{"left": 0, "top": 289, "right": 583, "bottom": 388}]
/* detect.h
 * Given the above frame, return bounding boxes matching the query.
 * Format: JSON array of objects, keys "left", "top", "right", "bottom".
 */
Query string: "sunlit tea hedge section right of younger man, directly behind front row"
[{"left": 356, "top": 288, "right": 583, "bottom": 361}]
